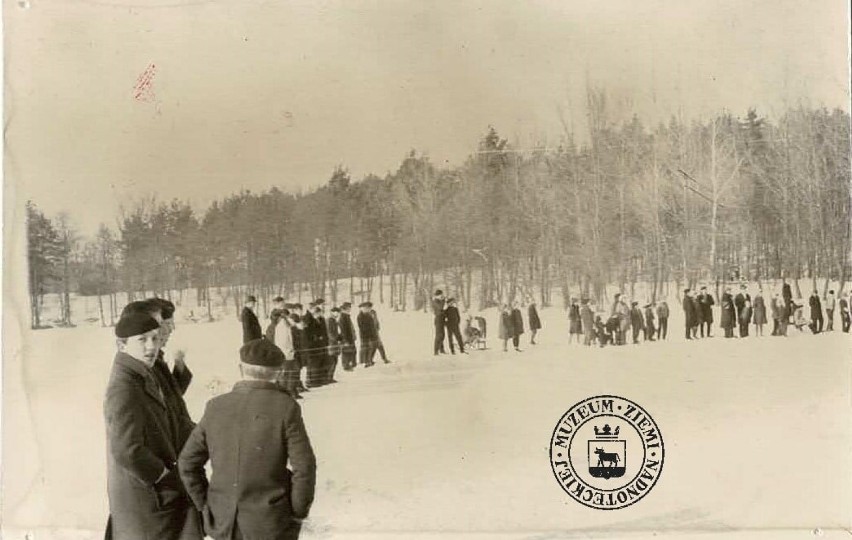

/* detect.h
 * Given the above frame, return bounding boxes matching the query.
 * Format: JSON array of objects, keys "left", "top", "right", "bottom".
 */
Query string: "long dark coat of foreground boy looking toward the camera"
[{"left": 104, "top": 353, "right": 203, "bottom": 540}]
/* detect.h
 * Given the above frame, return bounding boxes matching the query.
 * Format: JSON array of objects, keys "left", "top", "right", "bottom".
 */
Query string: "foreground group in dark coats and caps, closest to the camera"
[{"left": 104, "top": 298, "right": 316, "bottom": 540}]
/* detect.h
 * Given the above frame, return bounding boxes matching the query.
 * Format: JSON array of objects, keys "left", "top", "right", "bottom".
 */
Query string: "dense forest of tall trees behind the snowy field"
[{"left": 27, "top": 97, "right": 852, "bottom": 327}]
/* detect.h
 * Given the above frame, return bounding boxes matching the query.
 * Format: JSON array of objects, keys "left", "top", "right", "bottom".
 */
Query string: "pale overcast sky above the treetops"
[{"left": 4, "top": 0, "right": 850, "bottom": 234}]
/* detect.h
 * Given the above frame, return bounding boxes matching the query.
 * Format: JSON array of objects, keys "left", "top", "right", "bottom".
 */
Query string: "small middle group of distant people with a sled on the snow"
[{"left": 432, "top": 289, "right": 541, "bottom": 356}]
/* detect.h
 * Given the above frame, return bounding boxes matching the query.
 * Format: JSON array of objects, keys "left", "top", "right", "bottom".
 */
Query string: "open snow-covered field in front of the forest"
[{"left": 2, "top": 304, "right": 852, "bottom": 540}]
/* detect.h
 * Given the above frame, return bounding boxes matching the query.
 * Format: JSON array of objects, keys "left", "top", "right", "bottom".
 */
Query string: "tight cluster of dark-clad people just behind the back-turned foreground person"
[{"left": 240, "top": 296, "right": 390, "bottom": 399}]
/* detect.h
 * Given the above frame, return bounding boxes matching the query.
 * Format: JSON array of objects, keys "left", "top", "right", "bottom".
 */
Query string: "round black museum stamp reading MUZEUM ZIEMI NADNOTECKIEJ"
[{"left": 550, "top": 396, "right": 665, "bottom": 510}]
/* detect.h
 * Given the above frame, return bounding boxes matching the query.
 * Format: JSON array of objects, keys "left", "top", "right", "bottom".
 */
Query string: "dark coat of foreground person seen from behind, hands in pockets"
[{"left": 178, "top": 381, "right": 316, "bottom": 540}]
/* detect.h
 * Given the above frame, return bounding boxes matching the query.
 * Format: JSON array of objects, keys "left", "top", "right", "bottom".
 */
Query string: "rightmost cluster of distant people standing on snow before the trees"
[{"left": 683, "top": 282, "right": 852, "bottom": 339}]
